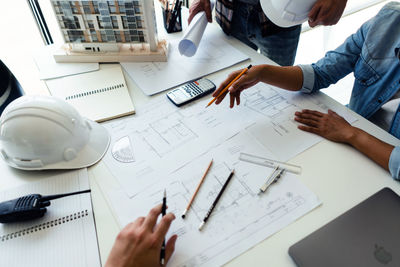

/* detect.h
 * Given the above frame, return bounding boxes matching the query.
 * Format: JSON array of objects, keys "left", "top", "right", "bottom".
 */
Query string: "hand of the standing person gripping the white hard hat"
[{"left": 308, "top": 0, "right": 347, "bottom": 27}]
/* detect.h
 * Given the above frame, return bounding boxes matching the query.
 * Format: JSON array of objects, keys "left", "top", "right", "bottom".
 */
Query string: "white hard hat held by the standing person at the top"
[{"left": 260, "top": 0, "right": 317, "bottom": 27}]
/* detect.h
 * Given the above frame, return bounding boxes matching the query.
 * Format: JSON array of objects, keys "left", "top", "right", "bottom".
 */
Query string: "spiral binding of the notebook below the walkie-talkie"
[{"left": 0, "top": 210, "right": 89, "bottom": 242}]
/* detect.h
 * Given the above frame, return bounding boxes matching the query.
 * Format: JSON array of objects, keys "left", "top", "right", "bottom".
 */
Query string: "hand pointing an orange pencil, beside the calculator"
[{"left": 212, "top": 65, "right": 264, "bottom": 108}]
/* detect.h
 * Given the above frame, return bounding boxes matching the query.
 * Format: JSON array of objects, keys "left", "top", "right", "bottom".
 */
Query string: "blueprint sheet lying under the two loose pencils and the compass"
[{"left": 104, "top": 132, "right": 320, "bottom": 266}]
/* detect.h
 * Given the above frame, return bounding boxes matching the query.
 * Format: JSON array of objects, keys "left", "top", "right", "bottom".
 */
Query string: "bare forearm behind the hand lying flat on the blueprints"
[{"left": 347, "top": 127, "right": 394, "bottom": 170}]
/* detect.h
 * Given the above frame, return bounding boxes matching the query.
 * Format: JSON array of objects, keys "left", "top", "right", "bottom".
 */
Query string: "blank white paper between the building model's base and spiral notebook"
[{"left": 33, "top": 45, "right": 99, "bottom": 80}]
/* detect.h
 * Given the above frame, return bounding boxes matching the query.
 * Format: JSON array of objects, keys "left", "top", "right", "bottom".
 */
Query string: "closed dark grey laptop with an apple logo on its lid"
[{"left": 289, "top": 188, "right": 400, "bottom": 267}]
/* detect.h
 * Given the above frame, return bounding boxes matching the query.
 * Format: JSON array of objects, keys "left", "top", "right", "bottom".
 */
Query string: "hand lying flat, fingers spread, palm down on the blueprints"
[{"left": 294, "top": 109, "right": 356, "bottom": 143}]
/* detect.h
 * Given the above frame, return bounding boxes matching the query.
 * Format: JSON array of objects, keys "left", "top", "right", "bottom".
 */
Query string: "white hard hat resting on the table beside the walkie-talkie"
[{"left": 0, "top": 96, "right": 110, "bottom": 170}]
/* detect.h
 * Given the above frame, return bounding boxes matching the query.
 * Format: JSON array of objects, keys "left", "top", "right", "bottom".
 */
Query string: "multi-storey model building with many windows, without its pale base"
[{"left": 51, "top": 0, "right": 167, "bottom": 62}]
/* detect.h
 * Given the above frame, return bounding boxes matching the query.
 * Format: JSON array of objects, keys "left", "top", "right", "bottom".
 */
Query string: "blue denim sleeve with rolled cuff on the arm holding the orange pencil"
[{"left": 299, "top": 18, "right": 374, "bottom": 93}]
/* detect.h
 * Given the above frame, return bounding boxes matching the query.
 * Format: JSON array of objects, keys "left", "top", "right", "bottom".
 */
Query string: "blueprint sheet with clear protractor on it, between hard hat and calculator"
[{"left": 103, "top": 96, "right": 252, "bottom": 197}]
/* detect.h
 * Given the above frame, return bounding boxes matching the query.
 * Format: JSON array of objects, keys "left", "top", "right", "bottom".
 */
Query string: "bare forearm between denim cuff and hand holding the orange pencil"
[{"left": 260, "top": 65, "right": 303, "bottom": 91}]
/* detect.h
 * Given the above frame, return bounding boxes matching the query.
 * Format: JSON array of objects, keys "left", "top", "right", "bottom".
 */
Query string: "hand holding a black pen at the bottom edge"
[{"left": 105, "top": 204, "right": 177, "bottom": 267}]
